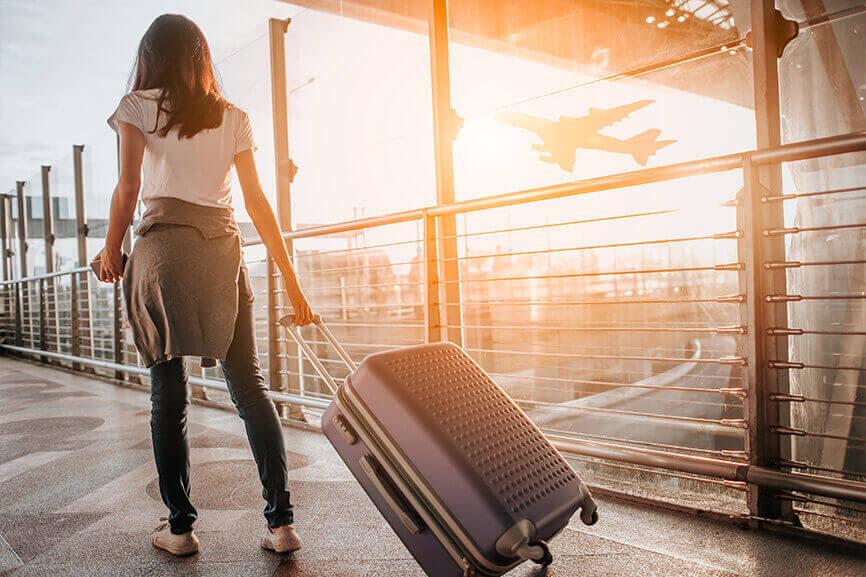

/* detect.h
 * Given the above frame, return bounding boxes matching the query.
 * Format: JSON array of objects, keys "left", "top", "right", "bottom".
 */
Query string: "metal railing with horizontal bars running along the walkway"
[{"left": 0, "top": 128, "right": 866, "bottom": 544}]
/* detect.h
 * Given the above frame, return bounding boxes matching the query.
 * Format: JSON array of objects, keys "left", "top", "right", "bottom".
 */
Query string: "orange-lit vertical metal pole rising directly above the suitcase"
[{"left": 429, "top": 0, "right": 463, "bottom": 344}]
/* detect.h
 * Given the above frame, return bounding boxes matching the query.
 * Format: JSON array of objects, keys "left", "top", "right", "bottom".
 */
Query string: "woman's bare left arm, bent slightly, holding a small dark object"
[{"left": 99, "top": 121, "right": 144, "bottom": 282}]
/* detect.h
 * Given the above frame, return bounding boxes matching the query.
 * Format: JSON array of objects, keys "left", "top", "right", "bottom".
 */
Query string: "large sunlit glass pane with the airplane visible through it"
[{"left": 451, "top": 1, "right": 755, "bottom": 199}]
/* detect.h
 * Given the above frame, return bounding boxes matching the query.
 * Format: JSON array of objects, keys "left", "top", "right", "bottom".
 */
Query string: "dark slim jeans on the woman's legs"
[{"left": 150, "top": 295, "right": 293, "bottom": 535}]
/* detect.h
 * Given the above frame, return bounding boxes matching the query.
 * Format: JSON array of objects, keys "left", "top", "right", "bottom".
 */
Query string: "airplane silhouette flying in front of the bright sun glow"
[{"left": 496, "top": 100, "right": 676, "bottom": 172}]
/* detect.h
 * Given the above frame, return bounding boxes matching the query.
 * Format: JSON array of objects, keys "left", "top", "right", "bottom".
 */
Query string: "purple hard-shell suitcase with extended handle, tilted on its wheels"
[{"left": 280, "top": 315, "right": 598, "bottom": 577}]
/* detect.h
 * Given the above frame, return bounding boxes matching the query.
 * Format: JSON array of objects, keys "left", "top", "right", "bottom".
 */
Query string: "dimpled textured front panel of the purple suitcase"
[{"left": 385, "top": 346, "right": 577, "bottom": 513}]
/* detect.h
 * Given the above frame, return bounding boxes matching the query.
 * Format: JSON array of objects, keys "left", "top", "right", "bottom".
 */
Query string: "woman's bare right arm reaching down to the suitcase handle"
[{"left": 235, "top": 150, "right": 313, "bottom": 326}]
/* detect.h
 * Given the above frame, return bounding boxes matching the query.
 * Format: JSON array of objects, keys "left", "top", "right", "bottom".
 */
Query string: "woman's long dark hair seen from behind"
[{"left": 131, "top": 14, "right": 230, "bottom": 138}]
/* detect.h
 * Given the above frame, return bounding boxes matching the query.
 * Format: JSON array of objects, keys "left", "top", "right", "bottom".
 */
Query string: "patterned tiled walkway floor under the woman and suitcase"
[{"left": 0, "top": 358, "right": 866, "bottom": 577}]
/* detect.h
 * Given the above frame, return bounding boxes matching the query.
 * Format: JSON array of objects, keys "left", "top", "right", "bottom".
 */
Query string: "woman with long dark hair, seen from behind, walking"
[{"left": 99, "top": 14, "right": 313, "bottom": 555}]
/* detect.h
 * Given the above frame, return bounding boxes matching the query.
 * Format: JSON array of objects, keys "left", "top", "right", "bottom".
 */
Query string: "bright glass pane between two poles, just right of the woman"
[{"left": 286, "top": 2, "right": 435, "bottom": 228}]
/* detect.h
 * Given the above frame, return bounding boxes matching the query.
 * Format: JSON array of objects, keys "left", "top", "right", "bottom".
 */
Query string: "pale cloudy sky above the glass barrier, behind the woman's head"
[{"left": 0, "top": 0, "right": 300, "bottom": 190}]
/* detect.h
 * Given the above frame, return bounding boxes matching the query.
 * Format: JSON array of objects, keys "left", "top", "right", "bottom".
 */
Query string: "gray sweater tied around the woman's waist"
[{"left": 123, "top": 198, "right": 253, "bottom": 367}]
